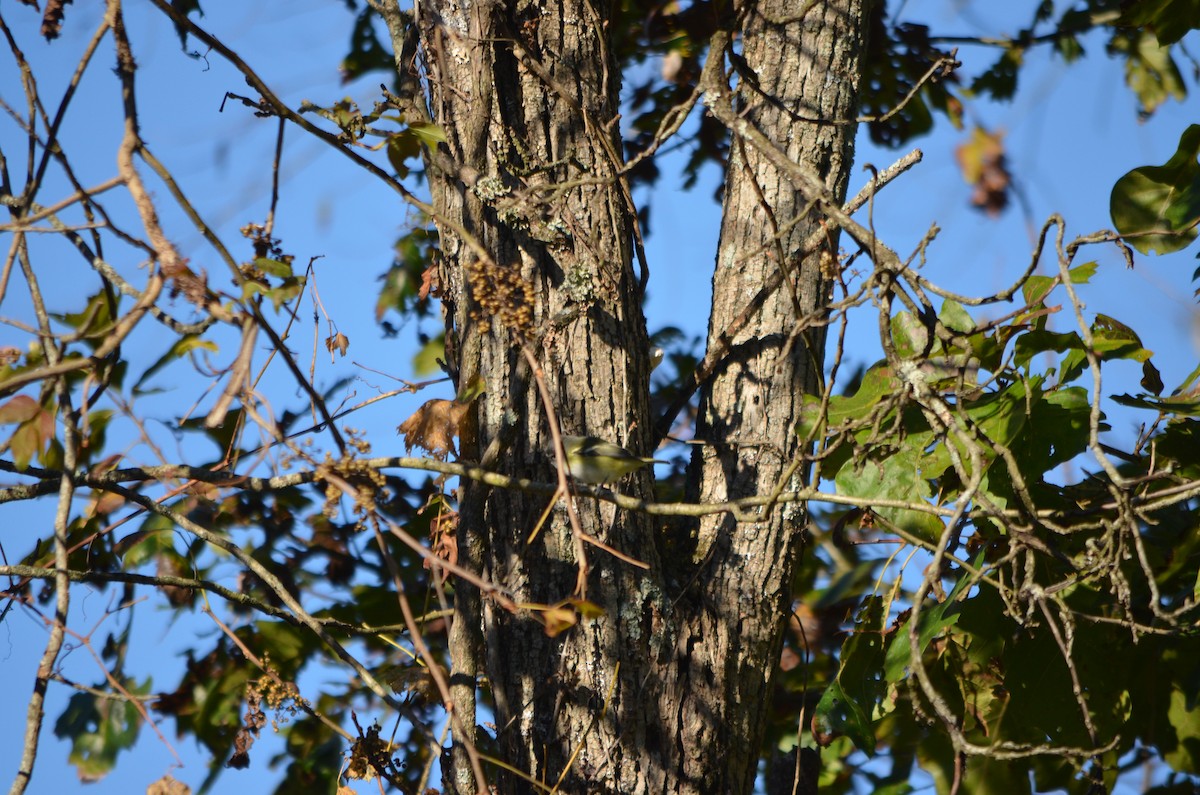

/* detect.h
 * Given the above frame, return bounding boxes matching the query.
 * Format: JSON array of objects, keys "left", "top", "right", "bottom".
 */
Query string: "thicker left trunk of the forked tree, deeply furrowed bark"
[{"left": 403, "top": 0, "right": 661, "bottom": 793}]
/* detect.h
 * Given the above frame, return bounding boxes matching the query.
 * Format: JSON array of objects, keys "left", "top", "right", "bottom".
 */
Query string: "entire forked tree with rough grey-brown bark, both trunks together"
[{"left": 388, "top": 0, "right": 865, "bottom": 794}]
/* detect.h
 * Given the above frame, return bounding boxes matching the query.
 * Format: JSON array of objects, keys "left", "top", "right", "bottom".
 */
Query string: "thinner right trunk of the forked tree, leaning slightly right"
[{"left": 671, "top": 0, "right": 870, "bottom": 793}]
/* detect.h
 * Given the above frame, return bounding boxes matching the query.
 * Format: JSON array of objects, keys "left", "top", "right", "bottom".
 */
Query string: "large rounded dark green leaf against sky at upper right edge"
[{"left": 1109, "top": 125, "right": 1200, "bottom": 255}]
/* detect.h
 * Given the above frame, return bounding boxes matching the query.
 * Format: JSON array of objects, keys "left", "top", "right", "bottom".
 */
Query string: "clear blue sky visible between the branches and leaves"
[{"left": 0, "top": 0, "right": 1198, "bottom": 795}]
